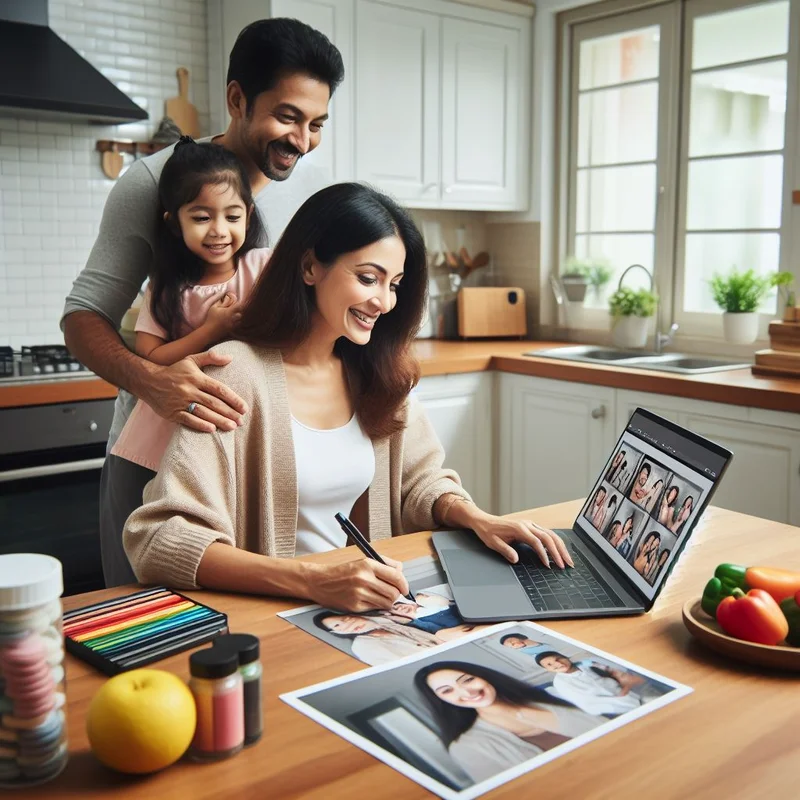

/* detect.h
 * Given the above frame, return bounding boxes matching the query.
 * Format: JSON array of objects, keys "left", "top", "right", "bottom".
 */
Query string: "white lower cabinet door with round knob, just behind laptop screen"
[{"left": 498, "top": 374, "right": 616, "bottom": 513}]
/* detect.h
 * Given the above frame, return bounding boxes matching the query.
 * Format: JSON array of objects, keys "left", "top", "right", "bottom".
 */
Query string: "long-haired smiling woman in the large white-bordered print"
[{"left": 414, "top": 661, "right": 606, "bottom": 783}]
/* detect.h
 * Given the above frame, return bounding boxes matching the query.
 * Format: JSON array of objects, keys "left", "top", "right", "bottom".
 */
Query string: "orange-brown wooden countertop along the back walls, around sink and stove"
[{"left": 6, "top": 339, "right": 800, "bottom": 412}]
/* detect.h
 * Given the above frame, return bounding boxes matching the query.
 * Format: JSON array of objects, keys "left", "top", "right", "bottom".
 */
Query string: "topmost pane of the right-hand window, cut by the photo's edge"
[{"left": 692, "top": 0, "right": 789, "bottom": 69}]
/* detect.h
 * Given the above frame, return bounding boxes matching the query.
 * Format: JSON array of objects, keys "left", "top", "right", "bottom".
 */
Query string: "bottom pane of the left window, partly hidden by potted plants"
[{"left": 575, "top": 233, "right": 654, "bottom": 309}]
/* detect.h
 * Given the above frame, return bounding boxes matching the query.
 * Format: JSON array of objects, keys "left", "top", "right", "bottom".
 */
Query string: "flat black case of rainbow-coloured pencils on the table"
[{"left": 64, "top": 586, "right": 228, "bottom": 675}]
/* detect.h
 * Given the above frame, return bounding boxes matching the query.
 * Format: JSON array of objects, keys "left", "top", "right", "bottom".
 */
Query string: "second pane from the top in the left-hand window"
[{"left": 578, "top": 81, "right": 658, "bottom": 167}]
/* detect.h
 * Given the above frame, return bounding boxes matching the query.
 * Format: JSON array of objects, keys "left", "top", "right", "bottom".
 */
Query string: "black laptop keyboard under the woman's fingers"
[{"left": 511, "top": 547, "right": 622, "bottom": 611}]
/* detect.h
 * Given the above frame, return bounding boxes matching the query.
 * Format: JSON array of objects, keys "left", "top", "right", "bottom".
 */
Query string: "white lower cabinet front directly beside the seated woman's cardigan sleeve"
[{"left": 415, "top": 372, "right": 496, "bottom": 512}]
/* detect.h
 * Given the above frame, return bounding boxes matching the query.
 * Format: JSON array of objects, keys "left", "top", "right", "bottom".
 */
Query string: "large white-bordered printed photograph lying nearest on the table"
[{"left": 281, "top": 622, "right": 691, "bottom": 798}]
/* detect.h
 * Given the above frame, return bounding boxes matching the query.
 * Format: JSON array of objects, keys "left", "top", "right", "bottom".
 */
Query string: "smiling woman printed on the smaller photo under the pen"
[{"left": 314, "top": 611, "right": 444, "bottom": 666}]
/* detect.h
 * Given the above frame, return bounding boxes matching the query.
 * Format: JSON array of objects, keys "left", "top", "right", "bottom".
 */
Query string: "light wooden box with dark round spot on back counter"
[{"left": 458, "top": 286, "right": 527, "bottom": 338}]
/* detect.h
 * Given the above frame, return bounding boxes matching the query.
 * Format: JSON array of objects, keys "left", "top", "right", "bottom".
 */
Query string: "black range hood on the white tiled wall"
[{"left": 0, "top": 0, "right": 147, "bottom": 124}]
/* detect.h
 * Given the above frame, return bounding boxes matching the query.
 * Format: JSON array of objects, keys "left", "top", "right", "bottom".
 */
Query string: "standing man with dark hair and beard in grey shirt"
[{"left": 62, "top": 19, "right": 344, "bottom": 586}]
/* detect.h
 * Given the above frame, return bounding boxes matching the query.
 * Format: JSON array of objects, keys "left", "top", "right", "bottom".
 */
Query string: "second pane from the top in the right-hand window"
[{"left": 689, "top": 61, "right": 786, "bottom": 156}]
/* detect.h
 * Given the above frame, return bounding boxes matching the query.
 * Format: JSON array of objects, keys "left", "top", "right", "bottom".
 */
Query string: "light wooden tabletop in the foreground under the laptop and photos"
[{"left": 48, "top": 501, "right": 800, "bottom": 800}]
